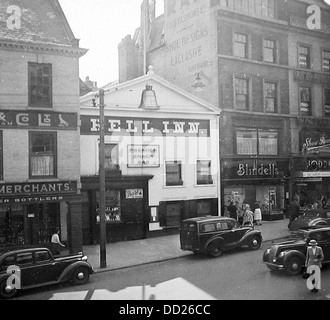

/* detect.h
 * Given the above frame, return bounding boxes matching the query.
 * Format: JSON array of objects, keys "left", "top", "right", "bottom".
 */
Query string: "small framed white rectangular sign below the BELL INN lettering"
[{"left": 127, "top": 145, "right": 160, "bottom": 168}]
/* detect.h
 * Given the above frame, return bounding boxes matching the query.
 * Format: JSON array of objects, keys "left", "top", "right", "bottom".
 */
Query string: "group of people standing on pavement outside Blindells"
[{"left": 227, "top": 200, "right": 262, "bottom": 226}]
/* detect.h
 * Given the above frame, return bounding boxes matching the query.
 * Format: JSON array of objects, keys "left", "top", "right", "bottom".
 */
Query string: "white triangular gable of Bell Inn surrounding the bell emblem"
[{"left": 80, "top": 67, "right": 220, "bottom": 115}]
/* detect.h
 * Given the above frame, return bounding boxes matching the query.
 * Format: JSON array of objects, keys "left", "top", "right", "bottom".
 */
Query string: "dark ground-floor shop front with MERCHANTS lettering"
[{"left": 0, "top": 181, "right": 80, "bottom": 251}]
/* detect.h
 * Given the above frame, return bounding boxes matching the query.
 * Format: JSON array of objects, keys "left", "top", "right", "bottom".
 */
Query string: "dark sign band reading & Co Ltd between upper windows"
[{"left": 0, "top": 110, "right": 78, "bottom": 130}]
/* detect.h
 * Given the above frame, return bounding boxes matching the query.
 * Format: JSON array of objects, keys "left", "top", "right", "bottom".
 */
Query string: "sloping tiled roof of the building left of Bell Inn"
[{"left": 0, "top": 0, "right": 86, "bottom": 52}]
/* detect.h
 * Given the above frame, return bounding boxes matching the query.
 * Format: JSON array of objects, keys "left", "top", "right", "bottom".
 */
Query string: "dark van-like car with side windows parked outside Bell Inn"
[{"left": 180, "top": 216, "right": 262, "bottom": 258}]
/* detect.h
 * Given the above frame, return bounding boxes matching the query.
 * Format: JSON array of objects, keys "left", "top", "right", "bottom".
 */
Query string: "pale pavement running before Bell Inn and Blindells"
[{"left": 83, "top": 218, "right": 290, "bottom": 273}]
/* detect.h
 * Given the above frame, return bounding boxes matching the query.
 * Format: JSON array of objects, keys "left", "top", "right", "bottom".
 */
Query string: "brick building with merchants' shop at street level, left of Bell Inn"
[{"left": 0, "top": 0, "right": 86, "bottom": 252}]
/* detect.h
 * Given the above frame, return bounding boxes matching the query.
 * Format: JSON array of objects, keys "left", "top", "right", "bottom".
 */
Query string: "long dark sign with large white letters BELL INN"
[{"left": 81, "top": 116, "right": 210, "bottom": 137}]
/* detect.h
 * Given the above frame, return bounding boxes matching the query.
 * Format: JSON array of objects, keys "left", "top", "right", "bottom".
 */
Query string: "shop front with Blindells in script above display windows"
[{"left": 222, "top": 158, "right": 289, "bottom": 221}]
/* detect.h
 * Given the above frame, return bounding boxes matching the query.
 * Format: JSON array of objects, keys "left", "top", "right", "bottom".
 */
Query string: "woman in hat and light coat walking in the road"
[{"left": 305, "top": 240, "right": 324, "bottom": 293}]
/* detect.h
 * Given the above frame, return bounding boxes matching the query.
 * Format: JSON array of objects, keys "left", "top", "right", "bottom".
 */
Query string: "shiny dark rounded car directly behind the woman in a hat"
[{"left": 262, "top": 226, "right": 330, "bottom": 275}]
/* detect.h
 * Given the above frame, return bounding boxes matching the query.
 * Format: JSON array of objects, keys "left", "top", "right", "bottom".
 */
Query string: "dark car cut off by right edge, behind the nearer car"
[{"left": 290, "top": 209, "right": 330, "bottom": 231}]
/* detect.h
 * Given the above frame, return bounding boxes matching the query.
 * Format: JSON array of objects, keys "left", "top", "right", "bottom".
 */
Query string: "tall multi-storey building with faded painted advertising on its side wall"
[{"left": 120, "top": 0, "right": 330, "bottom": 219}]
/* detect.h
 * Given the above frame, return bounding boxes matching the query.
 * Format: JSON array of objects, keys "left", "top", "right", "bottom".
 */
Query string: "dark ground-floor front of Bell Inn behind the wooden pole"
[{"left": 82, "top": 174, "right": 153, "bottom": 245}]
